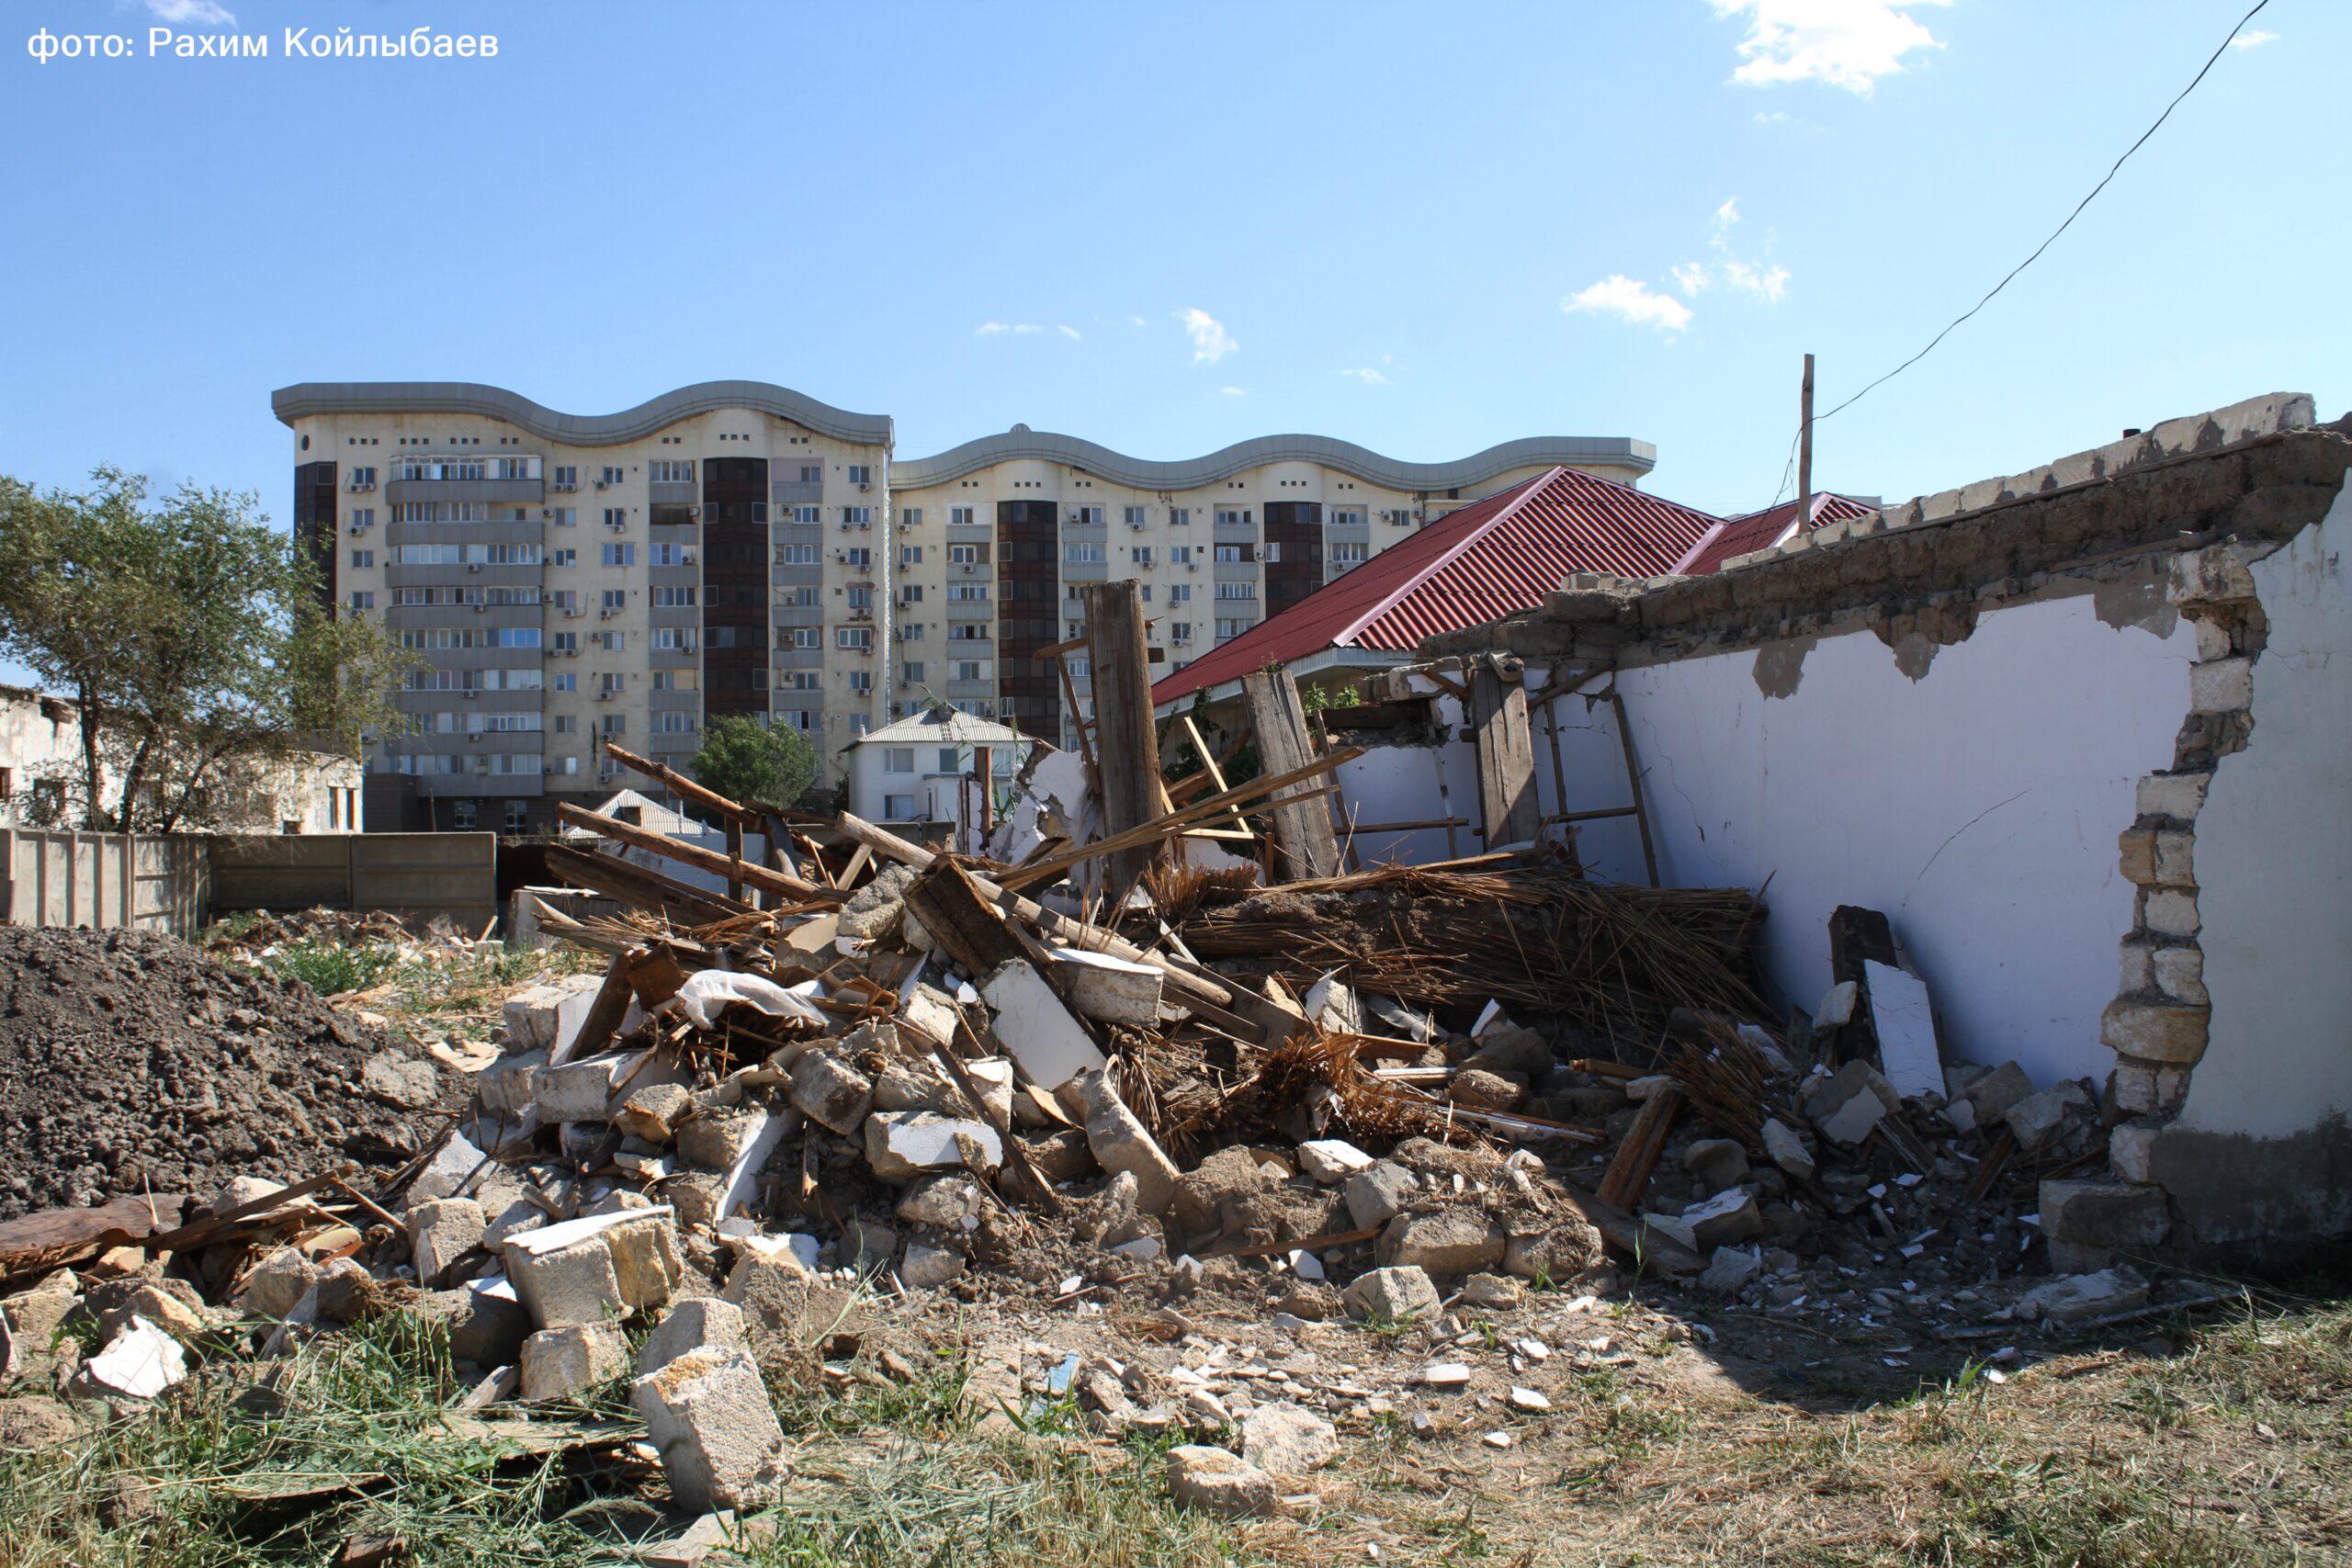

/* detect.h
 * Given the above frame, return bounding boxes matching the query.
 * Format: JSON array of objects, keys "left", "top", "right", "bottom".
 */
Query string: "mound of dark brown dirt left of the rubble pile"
[{"left": 0, "top": 926, "right": 466, "bottom": 1218}]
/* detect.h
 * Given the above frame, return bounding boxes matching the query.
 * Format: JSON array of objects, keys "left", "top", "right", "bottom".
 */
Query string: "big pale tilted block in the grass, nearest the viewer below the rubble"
[{"left": 630, "top": 1347, "right": 793, "bottom": 1512}]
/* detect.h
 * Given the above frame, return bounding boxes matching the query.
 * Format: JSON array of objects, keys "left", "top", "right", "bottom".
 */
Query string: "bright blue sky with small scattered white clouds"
[{"left": 0, "top": 0, "right": 2352, "bottom": 533}]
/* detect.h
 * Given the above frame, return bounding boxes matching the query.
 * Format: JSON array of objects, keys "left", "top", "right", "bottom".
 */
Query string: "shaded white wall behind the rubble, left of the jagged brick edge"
[{"left": 1536, "top": 594, "right": 2197, "bottom": 1084}]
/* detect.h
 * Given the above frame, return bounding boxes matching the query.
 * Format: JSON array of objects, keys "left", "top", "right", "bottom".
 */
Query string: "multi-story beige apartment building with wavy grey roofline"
[{"left": 270, "top": 381, "right": 1656, "bottom": 829}]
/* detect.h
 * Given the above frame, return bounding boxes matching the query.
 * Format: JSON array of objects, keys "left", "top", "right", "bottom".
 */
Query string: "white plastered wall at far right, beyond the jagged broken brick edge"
[{"left": 2178, "top": 489, "right": 2352, "bottom": 1138}]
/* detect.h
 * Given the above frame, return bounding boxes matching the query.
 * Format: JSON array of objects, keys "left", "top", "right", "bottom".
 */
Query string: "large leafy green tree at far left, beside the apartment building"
[{"left": 0, "top": 468, "right": 409, "bottom": 832}]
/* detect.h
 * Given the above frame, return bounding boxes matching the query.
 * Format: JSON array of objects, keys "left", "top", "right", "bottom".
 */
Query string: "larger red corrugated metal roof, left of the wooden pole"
[{"left": 1152, "top": 468, "right": 1717, "bottom": 703}]
